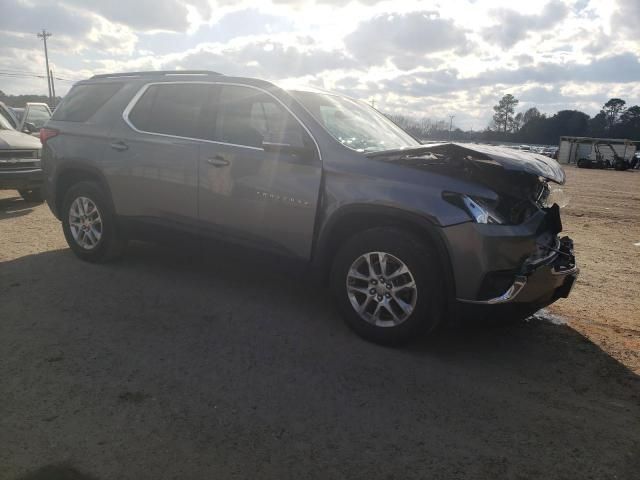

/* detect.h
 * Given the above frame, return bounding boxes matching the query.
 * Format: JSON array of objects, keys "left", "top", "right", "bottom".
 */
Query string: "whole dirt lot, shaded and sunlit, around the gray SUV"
[{"left": 0, "top": 169, "right": 640, "bottom": 480}]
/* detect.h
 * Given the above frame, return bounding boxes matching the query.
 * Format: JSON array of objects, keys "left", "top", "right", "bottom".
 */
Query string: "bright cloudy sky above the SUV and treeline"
[{"left": 0, "top": 0, "right": 640, "bottom": 130}]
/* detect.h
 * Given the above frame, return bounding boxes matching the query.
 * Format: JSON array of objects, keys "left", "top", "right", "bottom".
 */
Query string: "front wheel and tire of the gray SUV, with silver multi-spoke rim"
[{"left": 331, "top": 227, "right": 445, "bottom": 345}]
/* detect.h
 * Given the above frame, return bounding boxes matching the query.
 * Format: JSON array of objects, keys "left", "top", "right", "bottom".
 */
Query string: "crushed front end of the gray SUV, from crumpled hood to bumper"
[{"left": 422, "top": 145, "right": 579, "bottom": 316}]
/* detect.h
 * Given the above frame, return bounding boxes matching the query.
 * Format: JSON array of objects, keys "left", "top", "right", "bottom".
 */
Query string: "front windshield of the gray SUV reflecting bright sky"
[{"left": 290, "top": 91, "right": 420, "bottom": 152}]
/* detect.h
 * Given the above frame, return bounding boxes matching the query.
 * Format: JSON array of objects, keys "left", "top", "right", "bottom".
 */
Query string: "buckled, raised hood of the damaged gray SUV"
[{"left": 367, "top": 143, "right": 565, "bottom": 184}]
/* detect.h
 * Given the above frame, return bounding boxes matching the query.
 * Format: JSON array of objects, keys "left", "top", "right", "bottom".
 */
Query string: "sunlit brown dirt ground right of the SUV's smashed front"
[{"left": 550, "top": 168, "right": 640, "bottom": 374}]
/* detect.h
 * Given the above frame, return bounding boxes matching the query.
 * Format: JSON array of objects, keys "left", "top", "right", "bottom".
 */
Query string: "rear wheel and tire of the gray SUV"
[{"left": 62, "top": 181, "right": 126, "bottom": 263}]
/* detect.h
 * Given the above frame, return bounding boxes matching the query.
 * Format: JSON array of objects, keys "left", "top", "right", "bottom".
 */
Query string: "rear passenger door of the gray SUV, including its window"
[{"left": 105, "top": 82, "right": 210, "bottom": 230}]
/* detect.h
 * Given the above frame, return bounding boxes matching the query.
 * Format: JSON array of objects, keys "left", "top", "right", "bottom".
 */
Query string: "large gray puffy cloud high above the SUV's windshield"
[{"left": 345, "top": 11, "right": 469, "bottom": 69}]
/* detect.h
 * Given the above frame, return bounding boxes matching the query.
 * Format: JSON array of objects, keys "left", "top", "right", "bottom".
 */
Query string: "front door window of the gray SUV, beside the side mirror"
[{"left": 210, "top": 86, "right": 303, "bottom": 148}]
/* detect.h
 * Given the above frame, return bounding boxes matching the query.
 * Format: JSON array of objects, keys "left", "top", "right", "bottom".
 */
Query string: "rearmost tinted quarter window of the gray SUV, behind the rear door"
[{"left": 53, "top": 83, "right": 123, "bottom": 122}]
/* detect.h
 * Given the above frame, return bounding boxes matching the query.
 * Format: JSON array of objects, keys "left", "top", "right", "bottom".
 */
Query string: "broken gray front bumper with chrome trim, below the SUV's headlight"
[{"left": 443, "top": 208, "right": 579, "bottom": 312}]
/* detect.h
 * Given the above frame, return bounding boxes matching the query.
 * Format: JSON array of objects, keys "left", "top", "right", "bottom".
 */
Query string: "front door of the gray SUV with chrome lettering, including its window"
[{"left": 198, "top": 84, "right": 322, "bottom": 258}]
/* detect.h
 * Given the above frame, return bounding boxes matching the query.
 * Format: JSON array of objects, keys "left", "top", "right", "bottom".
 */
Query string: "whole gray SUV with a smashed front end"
[{"left": 41, "top": 71, "right": 578, "bottom": 344}]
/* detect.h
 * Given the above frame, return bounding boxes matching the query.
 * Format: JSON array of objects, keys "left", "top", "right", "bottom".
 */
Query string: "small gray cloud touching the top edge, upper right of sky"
[{"left": 482, "top": 0, "right": 568, "bottom": 48}]
